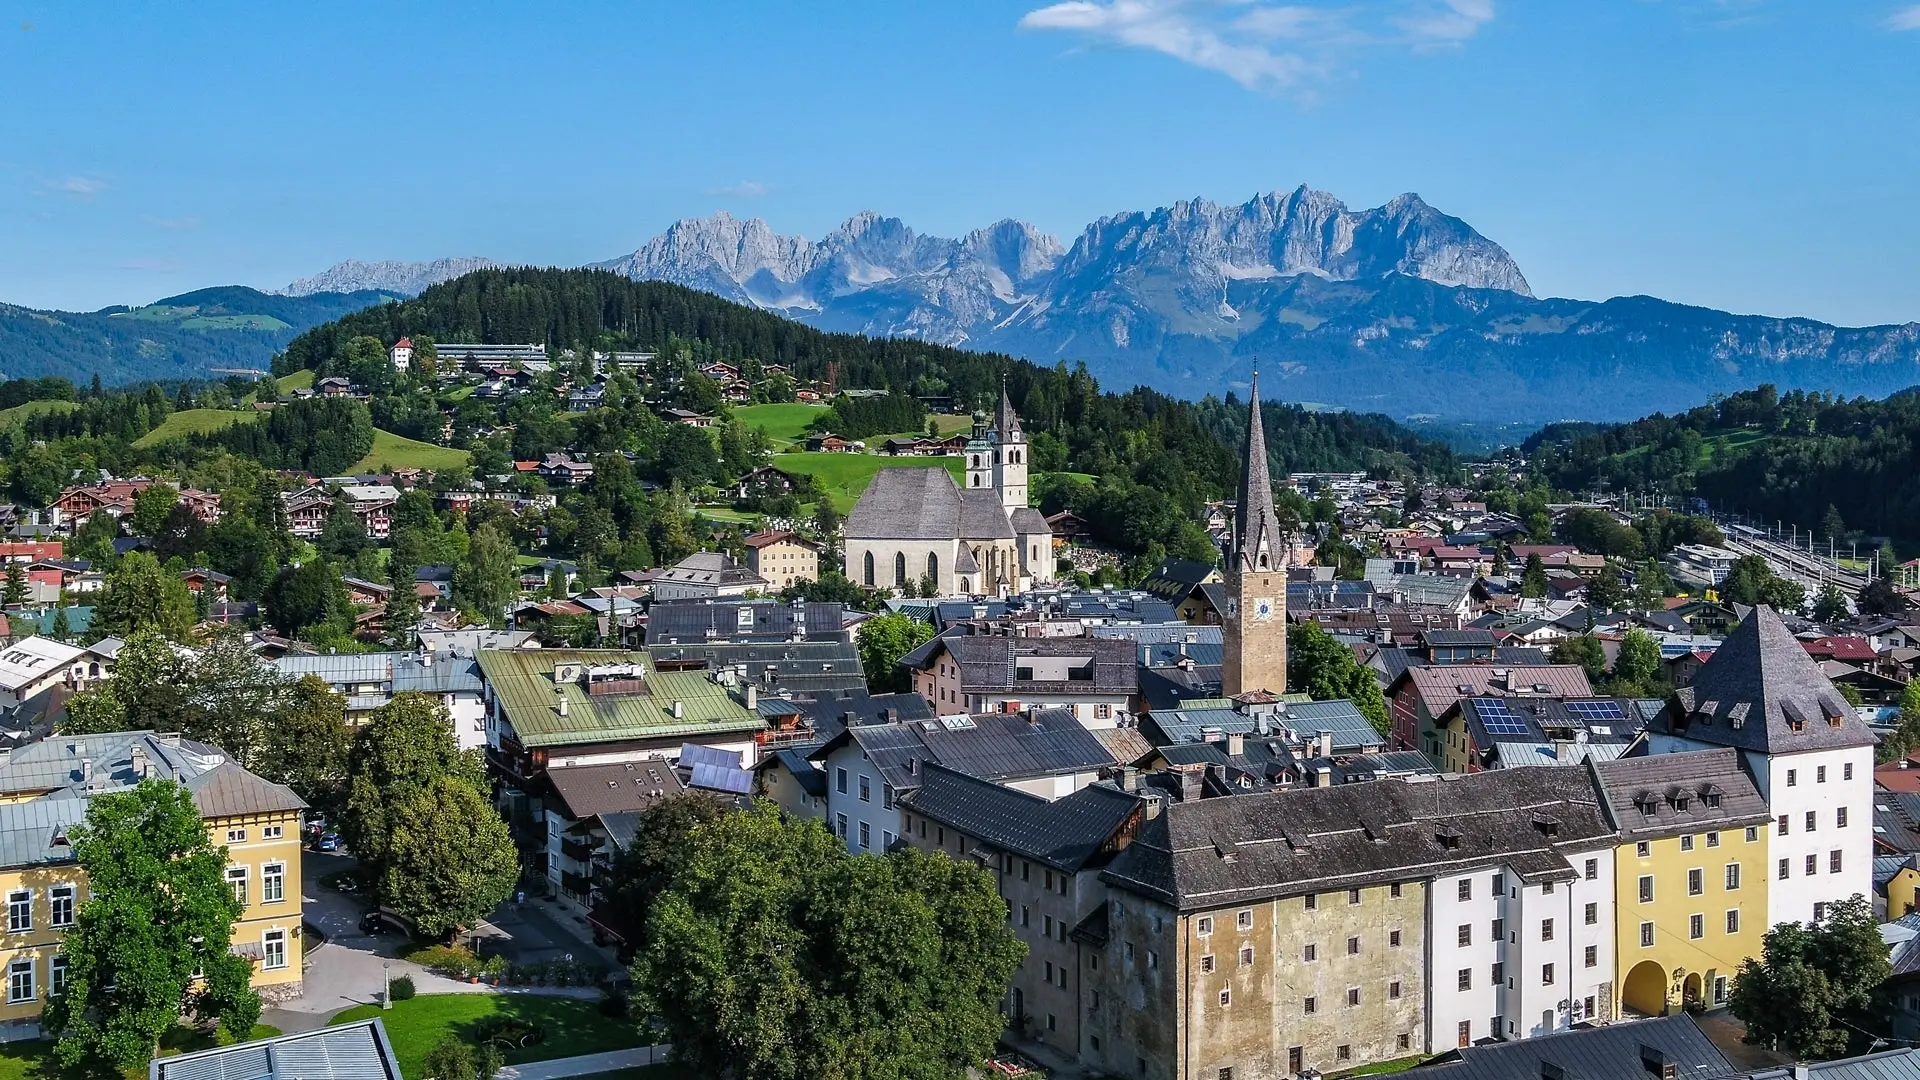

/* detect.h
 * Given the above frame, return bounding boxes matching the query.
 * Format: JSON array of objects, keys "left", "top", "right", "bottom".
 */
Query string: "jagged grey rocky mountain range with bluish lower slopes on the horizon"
[{"left": 255, "top": 186, "right": 1920, "bottom": 421}]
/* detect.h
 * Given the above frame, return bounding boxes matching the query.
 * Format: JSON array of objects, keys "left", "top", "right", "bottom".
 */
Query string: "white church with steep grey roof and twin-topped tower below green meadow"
[{"left": 841, "top": 386, "right": 1059, "bottom": 596}]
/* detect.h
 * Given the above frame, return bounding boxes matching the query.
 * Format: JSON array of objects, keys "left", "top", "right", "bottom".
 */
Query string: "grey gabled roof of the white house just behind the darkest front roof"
[{"left": 810, "top": 709, "right": 1116, "bottom": 792}]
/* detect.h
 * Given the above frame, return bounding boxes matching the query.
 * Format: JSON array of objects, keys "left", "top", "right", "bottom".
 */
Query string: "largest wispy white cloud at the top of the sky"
[{"left": 1020, "top": 0, "right": 1494, "bottom": 96}]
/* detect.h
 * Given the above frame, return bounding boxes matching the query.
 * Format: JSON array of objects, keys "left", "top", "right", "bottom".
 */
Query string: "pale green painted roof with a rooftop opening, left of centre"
[{"left": 480, "top": 650, "right": 766, "bottom": 748}]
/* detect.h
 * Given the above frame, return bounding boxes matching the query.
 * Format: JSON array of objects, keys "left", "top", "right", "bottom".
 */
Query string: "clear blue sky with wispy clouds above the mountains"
[{"left": 0, "top": 0, "right": 1920, "bottom": 323}]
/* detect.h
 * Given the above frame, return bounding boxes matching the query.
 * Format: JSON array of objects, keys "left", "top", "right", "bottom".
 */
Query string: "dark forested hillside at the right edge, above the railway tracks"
[{"left": 1524, "top": 384, "right": 1920, "bottom": 548}]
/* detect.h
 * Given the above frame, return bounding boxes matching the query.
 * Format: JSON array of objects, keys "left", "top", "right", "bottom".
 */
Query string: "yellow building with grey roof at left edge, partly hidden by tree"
[{"left": 0, "top": 732, "right": 307, "bottom": 1042}]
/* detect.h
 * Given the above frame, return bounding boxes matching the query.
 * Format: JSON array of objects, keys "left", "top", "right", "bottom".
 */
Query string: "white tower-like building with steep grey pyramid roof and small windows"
[{"left": 1645, "top": 607, "right": 1878, "bottom": 926}]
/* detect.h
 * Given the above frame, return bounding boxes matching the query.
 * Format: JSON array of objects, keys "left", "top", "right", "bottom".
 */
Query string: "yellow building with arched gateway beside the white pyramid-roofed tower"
[{"left": 1592, "top": 749, "right": 1772, "bottom": 1015}]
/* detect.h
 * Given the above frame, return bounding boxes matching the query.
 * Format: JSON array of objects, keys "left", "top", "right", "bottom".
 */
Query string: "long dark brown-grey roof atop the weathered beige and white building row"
[{"left": 1104, "top": 769, "right": 1615, "bottom": 911}]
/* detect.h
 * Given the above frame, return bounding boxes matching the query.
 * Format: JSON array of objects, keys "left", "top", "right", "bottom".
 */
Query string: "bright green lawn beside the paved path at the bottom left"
[{"left": 334, "top": 994, "right": 659, "bottom": 1080}]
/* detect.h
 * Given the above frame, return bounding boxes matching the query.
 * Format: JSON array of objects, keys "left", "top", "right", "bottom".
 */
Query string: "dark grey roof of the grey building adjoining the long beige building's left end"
[{"left": 904, "top": 763, "right": 1146, "bottom": 872}]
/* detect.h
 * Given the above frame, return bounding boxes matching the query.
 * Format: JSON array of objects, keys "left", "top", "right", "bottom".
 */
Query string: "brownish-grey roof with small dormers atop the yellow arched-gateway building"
[{"left": 1594, "top": 748, "right": 1772, "bottom": 840}]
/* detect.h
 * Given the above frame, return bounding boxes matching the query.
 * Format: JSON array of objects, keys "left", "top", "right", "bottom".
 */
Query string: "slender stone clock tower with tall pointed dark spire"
[{"left": 1219, "top": 371, "right": 1286, "bottom": 698}]
